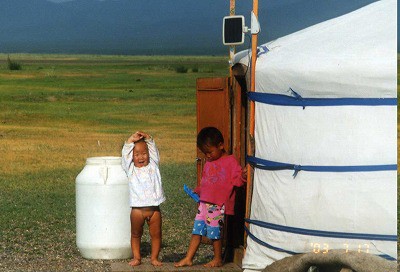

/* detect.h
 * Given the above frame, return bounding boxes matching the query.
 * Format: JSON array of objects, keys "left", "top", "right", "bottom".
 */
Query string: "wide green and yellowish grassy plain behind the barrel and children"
[{"left": 0, "top": 54, "right": 228, "bottom": 271}]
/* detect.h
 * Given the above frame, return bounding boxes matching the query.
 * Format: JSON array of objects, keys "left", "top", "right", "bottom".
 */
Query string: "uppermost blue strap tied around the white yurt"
[{"left": 247, "top": 89, "right": 397, "bottom": 109}]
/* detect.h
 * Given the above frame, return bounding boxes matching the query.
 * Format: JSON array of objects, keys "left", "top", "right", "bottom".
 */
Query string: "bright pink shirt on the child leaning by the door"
[{"left": 194, "top": 155, "right": 244, "bottom": 214}]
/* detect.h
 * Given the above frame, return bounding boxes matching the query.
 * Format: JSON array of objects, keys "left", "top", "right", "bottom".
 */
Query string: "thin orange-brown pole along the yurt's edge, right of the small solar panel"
[{"left": 245, "top": 0, "right": 258, "bottom": 248}]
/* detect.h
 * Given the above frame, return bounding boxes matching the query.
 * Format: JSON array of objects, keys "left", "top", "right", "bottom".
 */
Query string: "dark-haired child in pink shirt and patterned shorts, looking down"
[{"left": 175, "top": 127, "right": 246, "bottom": 267}]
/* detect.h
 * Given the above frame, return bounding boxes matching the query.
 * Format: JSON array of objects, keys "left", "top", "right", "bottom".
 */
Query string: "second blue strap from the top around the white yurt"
[{"left": 247, "top": 156, "right": 397, "bottom": 177}]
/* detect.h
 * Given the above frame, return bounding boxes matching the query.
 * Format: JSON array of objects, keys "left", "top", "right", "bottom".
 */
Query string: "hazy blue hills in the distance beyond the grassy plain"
[{"left": 0, "top": 0, "right": 382, "bottom": 55}]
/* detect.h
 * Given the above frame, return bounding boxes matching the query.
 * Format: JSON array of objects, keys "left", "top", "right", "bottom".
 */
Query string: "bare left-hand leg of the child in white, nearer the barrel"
[{"left": 129, "top": 208, "right": 144, "bottom": 266}]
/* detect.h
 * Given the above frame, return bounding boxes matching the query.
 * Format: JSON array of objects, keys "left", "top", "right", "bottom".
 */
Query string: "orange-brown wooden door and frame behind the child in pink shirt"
[{"left": 196, "top": 78, "right": 247, "bottom": 264}]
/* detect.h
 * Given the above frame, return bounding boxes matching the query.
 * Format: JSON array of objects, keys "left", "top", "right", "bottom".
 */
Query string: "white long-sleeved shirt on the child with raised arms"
[{"left": 122, "top": 138, "right": 165, "bottom": 207}]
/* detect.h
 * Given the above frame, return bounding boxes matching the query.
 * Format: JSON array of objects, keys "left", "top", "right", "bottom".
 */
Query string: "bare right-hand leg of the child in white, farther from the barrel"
[{"left": 148, "top": 211, "right": 162, "bottom": 266}]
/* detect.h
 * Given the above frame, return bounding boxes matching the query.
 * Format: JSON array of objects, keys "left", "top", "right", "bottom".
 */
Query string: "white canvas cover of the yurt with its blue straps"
[{"left": 234, "top": 0, "right": 397, "bottom": 271}]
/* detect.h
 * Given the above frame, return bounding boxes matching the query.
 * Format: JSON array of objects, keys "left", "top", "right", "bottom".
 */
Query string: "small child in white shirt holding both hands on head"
[{"left": 122, "top": 131, "right": 165, "bottom": 266}]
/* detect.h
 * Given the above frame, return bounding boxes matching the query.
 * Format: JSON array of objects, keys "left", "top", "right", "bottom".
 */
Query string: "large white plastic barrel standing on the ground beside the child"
[{"left": 76, "top": 157, "right": 132, "bottom": 259}]
